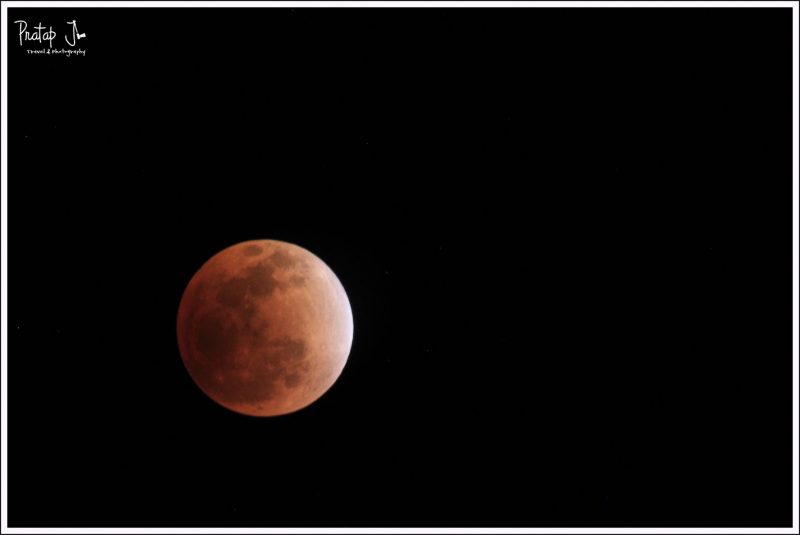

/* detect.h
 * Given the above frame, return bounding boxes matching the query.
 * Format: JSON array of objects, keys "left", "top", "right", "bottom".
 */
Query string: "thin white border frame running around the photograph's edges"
[{"left": 0, "top": 1, "right": 800, "bottom": 534}]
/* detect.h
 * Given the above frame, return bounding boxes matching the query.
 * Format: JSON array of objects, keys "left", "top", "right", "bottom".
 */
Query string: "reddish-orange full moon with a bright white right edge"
[{"left": 178, "top": 240, "right": 353, "bottom": 416}]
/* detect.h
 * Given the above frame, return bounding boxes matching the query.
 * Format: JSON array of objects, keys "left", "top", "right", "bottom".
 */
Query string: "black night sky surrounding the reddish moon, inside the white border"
[{"left": 8, "top": 8, "right": 792, "bottom": 526}]
